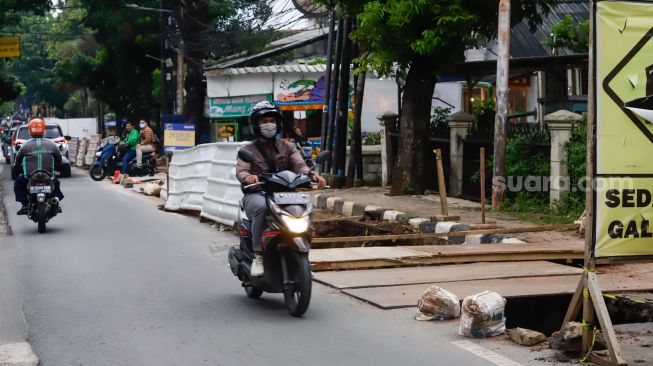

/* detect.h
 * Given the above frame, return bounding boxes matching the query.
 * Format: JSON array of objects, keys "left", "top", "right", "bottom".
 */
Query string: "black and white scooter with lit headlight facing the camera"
[{"left": 229, "top": 150, "right": 330, "bottom": 317}]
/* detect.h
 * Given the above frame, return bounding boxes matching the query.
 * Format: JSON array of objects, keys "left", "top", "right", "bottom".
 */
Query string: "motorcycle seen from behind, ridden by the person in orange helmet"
[{"left": 27, "top": 170, "right": 59, "bottom": 234}]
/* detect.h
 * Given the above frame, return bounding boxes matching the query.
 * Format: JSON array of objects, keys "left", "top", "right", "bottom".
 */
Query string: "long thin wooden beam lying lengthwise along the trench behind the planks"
[{"left": 311, "top": 224, "right": 578, "bottom": 244}]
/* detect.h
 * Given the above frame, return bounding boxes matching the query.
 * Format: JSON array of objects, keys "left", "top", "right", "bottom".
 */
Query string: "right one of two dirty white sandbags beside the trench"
[{"left": 458, "top": 291, "right": 506, "bottom": 338}]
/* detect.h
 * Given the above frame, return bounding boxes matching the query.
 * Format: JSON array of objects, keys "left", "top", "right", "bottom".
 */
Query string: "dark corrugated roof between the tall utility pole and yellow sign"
[{"left": 510, "top": 0, "right": 590, "bottom": 58}]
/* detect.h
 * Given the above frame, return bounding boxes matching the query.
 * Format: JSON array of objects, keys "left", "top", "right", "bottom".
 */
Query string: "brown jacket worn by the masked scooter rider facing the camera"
[{"left": 236, "top": 140, "right": 311, "bottom": 183}]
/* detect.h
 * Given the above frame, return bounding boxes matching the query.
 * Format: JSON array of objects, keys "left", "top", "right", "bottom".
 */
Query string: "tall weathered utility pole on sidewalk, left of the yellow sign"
[{"left": 492, "top": 0, "right": 510, "bottom": 210}]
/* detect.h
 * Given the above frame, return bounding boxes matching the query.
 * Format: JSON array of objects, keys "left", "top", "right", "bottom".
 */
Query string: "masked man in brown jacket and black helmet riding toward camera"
[{"left": 236, "top": 101, "right": 326, "bottom": 277}]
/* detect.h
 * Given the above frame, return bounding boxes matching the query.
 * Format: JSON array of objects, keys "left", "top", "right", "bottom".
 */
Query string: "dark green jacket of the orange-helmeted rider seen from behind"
[{"left": 13, "top": 138, "right": 62, "bottom": 177}]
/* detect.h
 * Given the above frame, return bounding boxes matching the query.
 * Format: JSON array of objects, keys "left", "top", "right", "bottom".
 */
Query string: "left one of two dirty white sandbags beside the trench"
[{"left": 415, "top": 285, "right": 460, "bottom": 320}]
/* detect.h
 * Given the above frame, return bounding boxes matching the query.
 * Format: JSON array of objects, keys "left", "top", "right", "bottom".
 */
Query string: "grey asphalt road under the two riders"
[{"left": 0, "top": 166, "right": 524, "bottom": 366}]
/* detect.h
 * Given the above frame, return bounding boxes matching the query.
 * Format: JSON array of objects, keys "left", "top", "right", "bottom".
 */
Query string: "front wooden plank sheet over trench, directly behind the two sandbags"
[{"left": 343, "top": 265, "right": 653, "bottom": 309}]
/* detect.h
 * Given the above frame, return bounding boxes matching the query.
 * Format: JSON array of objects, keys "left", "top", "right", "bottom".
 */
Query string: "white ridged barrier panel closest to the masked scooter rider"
[{"left": 200, "top": 142, "right": 247, "bottom": 226}]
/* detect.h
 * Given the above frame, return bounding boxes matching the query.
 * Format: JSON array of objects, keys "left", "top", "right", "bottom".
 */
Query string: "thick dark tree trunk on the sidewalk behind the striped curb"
[{"left": 390, "top": 57, "right": 437, "bottom": 195}]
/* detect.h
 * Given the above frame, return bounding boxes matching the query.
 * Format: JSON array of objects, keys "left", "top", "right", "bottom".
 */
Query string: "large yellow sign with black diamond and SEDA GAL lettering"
[{"left": 593, "top": 1, "right": 653, "bottom": 257}]
